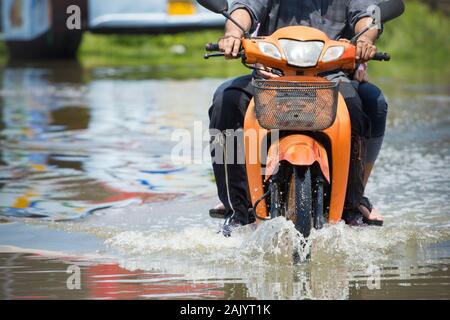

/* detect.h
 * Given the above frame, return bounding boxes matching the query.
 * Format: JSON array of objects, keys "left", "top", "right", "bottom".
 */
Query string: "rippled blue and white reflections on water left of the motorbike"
[{"left": 0, "top": 63, "right": 216, "bottom": 220}]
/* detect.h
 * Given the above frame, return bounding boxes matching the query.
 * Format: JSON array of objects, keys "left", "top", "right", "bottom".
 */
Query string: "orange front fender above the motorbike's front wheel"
[{"left": 266, "top": 134, "right": 330, "bottom": 183}]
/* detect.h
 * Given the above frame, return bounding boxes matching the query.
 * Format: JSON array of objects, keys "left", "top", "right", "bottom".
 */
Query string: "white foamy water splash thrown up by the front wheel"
[{"left": 106, "top": 217, "right": 450, "bottom": 270}]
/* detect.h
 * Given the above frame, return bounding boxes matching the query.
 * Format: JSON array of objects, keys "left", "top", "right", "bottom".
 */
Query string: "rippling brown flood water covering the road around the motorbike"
[{"left": 0, "top": 63, "right": 450, "bottom": 299}]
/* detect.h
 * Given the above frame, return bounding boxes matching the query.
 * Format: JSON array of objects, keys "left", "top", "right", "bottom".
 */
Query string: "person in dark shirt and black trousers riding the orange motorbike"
[{"left": 209, "top": 0, "right": 387, "bottom": 236}]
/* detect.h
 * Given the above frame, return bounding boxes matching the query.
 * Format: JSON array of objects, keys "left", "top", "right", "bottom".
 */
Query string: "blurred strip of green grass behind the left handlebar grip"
[{"left": 79, "top": 31, "right": 248, "bottom": 78}]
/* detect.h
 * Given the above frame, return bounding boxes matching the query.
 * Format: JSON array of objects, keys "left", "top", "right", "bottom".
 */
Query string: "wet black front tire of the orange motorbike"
[{"left": 285, "top": 167, "right": 313, "bottom": 238}]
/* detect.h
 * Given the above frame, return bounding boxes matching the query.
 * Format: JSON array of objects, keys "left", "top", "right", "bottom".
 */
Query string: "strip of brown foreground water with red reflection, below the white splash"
[{"left": 0, "top": 240, "right": 450, "bottom": 300}]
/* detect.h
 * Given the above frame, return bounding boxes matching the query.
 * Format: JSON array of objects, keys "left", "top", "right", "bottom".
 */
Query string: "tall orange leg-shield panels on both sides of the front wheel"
[{"left": 244, "top": 76, "right": 351, "bottom": 223}]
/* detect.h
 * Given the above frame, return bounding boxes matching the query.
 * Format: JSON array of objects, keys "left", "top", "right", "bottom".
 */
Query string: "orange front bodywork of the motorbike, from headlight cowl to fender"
[{"left": 242, "top": 26, "right": 356, "bottom": 222}]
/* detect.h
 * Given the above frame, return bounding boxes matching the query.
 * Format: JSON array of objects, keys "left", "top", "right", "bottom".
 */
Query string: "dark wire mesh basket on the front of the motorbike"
[{"left": 253, "top": 79, "right": 338, "bottom": 131}]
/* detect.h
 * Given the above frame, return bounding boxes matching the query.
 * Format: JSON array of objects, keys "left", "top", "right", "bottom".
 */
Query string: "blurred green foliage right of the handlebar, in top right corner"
[{"left": 371, "top": 1, "right": 450, "bottom": 81}]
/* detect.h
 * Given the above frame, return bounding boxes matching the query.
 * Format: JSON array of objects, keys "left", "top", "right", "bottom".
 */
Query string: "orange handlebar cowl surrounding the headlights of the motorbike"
[{"left": 242, "top": 26, "right": 356, "bottom": 75}]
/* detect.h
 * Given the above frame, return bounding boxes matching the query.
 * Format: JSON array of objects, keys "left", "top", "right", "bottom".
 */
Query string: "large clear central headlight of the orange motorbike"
[{"left": 278, "top": 39, "right": 323, "bottom": 67}]
